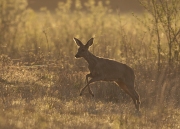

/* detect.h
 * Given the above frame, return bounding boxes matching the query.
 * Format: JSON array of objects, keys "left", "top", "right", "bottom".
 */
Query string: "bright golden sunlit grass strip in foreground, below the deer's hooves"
[{"left": 0, "top": 94, "right": 180, "bottom": 129}]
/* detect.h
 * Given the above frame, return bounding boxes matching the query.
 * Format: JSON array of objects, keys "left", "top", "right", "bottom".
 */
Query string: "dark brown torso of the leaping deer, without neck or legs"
[{"left": 87, "top": 56, "right": 134, "bottom": 81}]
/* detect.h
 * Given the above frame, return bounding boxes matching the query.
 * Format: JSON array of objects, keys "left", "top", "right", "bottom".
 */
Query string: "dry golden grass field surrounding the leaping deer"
[{"left": 0, "top": 0, "right": 180, "bottom": 129}]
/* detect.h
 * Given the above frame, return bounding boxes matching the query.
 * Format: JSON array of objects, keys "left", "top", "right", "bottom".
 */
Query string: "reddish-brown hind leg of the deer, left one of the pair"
[{"left": 116, "top": 81, "right": 139, "bottom": 111}]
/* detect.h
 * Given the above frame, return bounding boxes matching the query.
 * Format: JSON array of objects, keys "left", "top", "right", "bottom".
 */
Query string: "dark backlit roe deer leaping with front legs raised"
[{"left": 74, "top": 38, "right": 140, "bottom": 111}]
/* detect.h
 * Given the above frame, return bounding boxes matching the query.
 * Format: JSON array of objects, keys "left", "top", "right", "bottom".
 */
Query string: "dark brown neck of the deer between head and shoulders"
[{"left": 84, "top": 52, "right": 98, "bottom": 66}]
